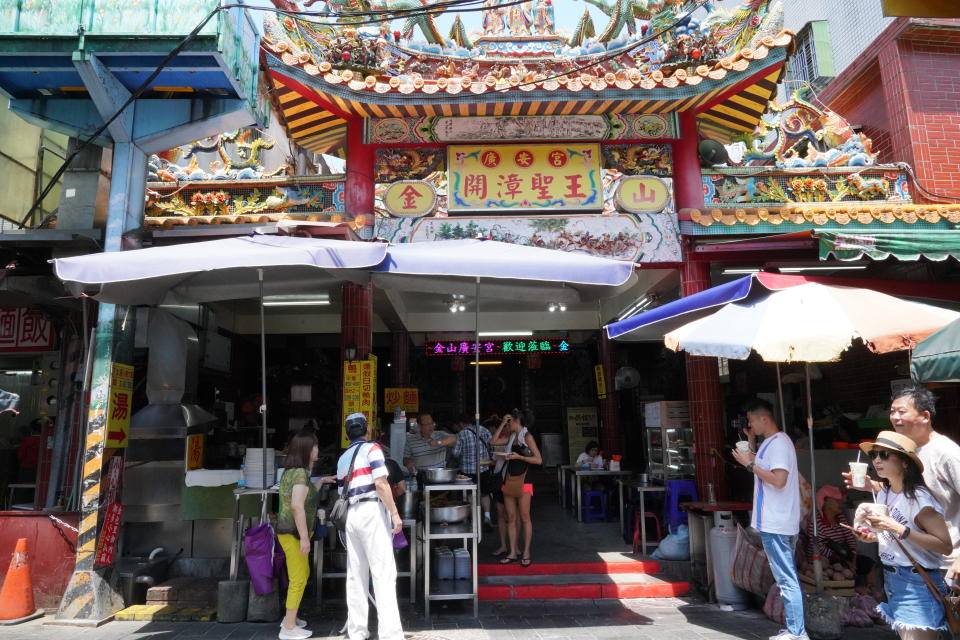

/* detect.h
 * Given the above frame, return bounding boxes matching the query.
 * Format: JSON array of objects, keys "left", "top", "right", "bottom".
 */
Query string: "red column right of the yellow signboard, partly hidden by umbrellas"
[{"left": 673, "top": 111, "right": 728, "bottom": 500}]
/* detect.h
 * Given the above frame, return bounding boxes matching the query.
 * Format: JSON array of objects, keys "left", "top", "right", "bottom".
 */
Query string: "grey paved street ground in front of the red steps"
[{"left": 0, "top": 598, "right": 896, "bottom": 640}]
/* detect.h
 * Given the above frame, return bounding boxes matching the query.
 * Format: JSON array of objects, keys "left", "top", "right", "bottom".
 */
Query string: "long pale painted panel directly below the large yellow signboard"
[{"left": 375, "top": 213, "right": 681, "bottom": 262}]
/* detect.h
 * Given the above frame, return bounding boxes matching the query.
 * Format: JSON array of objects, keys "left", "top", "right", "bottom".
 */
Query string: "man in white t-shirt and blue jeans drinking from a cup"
[{"left": 733, "top": 400, "right": 809, "bottom": 640}]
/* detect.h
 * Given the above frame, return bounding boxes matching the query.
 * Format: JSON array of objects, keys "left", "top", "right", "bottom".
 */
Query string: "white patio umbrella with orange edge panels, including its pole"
[{"left": 663, "top": 282, "right": 960, "bottom": 592}]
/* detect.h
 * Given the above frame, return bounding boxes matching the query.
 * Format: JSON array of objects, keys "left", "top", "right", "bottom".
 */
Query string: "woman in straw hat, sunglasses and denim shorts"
[{"left": 851, "top": 431, "right": 953, "bottom": 640}]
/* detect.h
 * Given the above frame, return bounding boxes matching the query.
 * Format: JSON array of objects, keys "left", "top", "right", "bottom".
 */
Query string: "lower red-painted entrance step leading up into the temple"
[{"left": 477, "top": 565, "right": 690, "bottom": 600}]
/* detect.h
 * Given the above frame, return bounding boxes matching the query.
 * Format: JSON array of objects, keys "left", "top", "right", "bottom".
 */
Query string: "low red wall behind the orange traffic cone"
[{"left": 0, "top": 511, "right": 80, "bottom": 610}]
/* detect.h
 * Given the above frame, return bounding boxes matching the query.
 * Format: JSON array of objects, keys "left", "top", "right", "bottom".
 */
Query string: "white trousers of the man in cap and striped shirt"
[{"left": 346, "top": 500, "right": 403, "bottom": 640}]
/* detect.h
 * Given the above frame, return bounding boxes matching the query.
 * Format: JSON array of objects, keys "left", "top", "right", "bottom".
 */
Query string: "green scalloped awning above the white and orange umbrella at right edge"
[{"left": 813, "top": 229, "right": 960, "bottom": 262}]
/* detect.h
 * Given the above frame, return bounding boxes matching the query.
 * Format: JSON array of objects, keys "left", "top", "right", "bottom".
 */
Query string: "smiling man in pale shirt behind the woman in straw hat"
[{"left": 843, "top": 387, "right": 960, "bottom": 596}]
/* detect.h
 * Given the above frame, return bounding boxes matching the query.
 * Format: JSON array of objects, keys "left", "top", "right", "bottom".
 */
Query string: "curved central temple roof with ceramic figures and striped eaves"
[{"left": 263, "top": 0, "right": 793, "bottom": 151}]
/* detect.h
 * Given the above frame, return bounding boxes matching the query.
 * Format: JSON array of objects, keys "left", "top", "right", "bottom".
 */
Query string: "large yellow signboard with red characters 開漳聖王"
[{"left": 447, "top": 143, "right": 603, "bottom": 213}]
